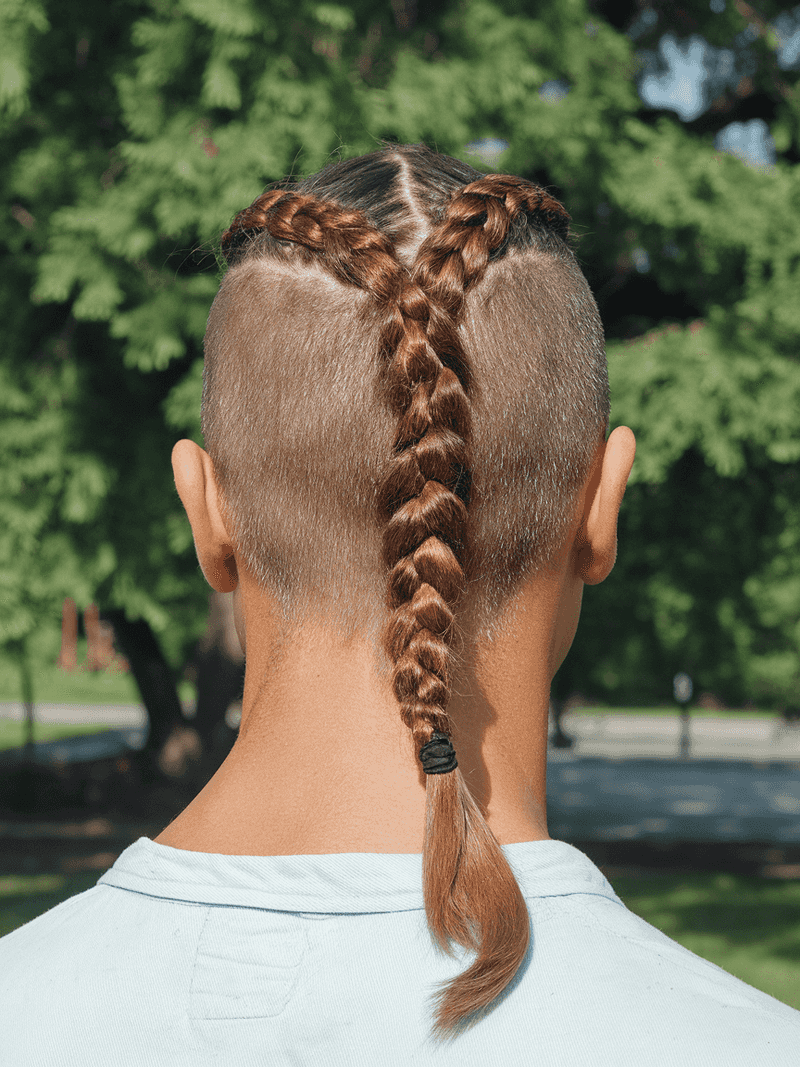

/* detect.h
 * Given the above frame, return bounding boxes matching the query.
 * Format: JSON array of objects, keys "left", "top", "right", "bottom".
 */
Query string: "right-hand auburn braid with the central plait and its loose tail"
[{"left": 381, "top": 175, "right": 569, "bottom": 1036}]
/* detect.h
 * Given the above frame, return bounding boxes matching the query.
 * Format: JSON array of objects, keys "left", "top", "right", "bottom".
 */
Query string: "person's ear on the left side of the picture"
[{"left": 172, "top": 441, "right": 239, "bottom": 593}]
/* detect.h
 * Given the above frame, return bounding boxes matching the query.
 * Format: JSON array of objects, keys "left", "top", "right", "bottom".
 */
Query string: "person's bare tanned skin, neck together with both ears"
[{"left": 156, "top": 427, "right": 636, "bottom": 856}]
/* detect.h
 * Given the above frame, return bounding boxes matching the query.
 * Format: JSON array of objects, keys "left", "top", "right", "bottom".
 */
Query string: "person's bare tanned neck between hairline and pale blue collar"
[{"left": 156, "top": 582, "right": 560, "bottom": 856}]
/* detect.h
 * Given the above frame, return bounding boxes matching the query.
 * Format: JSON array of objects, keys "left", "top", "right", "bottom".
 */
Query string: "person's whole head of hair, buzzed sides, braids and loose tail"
[{"left": 203, "top": 146, "right": 608, "bottom": 1035}]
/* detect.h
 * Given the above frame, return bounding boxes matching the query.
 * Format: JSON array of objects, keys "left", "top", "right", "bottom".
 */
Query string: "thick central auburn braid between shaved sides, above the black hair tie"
[{"left": 381, "top": 271, "right": 469, "bottom": 753}]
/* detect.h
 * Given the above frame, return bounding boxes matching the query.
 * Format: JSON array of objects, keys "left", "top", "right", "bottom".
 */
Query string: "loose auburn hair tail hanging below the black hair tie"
[{"left": 422, "top": 769, "right": 530, "bottom": 1041}]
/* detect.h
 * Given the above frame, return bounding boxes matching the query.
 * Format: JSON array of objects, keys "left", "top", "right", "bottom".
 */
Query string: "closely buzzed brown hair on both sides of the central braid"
[{"left": 203, "top": 168, "right": 608, "bottom": 631}]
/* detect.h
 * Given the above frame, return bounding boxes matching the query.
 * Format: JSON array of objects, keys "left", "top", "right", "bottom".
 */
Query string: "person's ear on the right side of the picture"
[{"left": 576, "top": 426, "right": 636, "bottom": 586}]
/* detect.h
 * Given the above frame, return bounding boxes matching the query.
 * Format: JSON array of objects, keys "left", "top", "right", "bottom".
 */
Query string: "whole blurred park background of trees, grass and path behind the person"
[{"left": 0, "top": 0, "right": 800, "bottom": 1007}]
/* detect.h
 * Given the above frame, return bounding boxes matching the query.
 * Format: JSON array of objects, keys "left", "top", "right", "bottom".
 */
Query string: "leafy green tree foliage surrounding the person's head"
[{"left": 0, "top": 0, "right": 800, "bottom": 703}]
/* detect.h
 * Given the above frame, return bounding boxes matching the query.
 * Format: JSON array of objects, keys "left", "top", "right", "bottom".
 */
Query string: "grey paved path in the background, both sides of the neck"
[{"left": 0, "top": 704, "right": 800, "bottom": 844}]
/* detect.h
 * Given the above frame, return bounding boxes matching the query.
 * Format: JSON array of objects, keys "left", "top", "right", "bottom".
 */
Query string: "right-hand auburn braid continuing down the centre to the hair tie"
[{"left": 381, "top": 175, "right": 569, "bottom": 773}]
